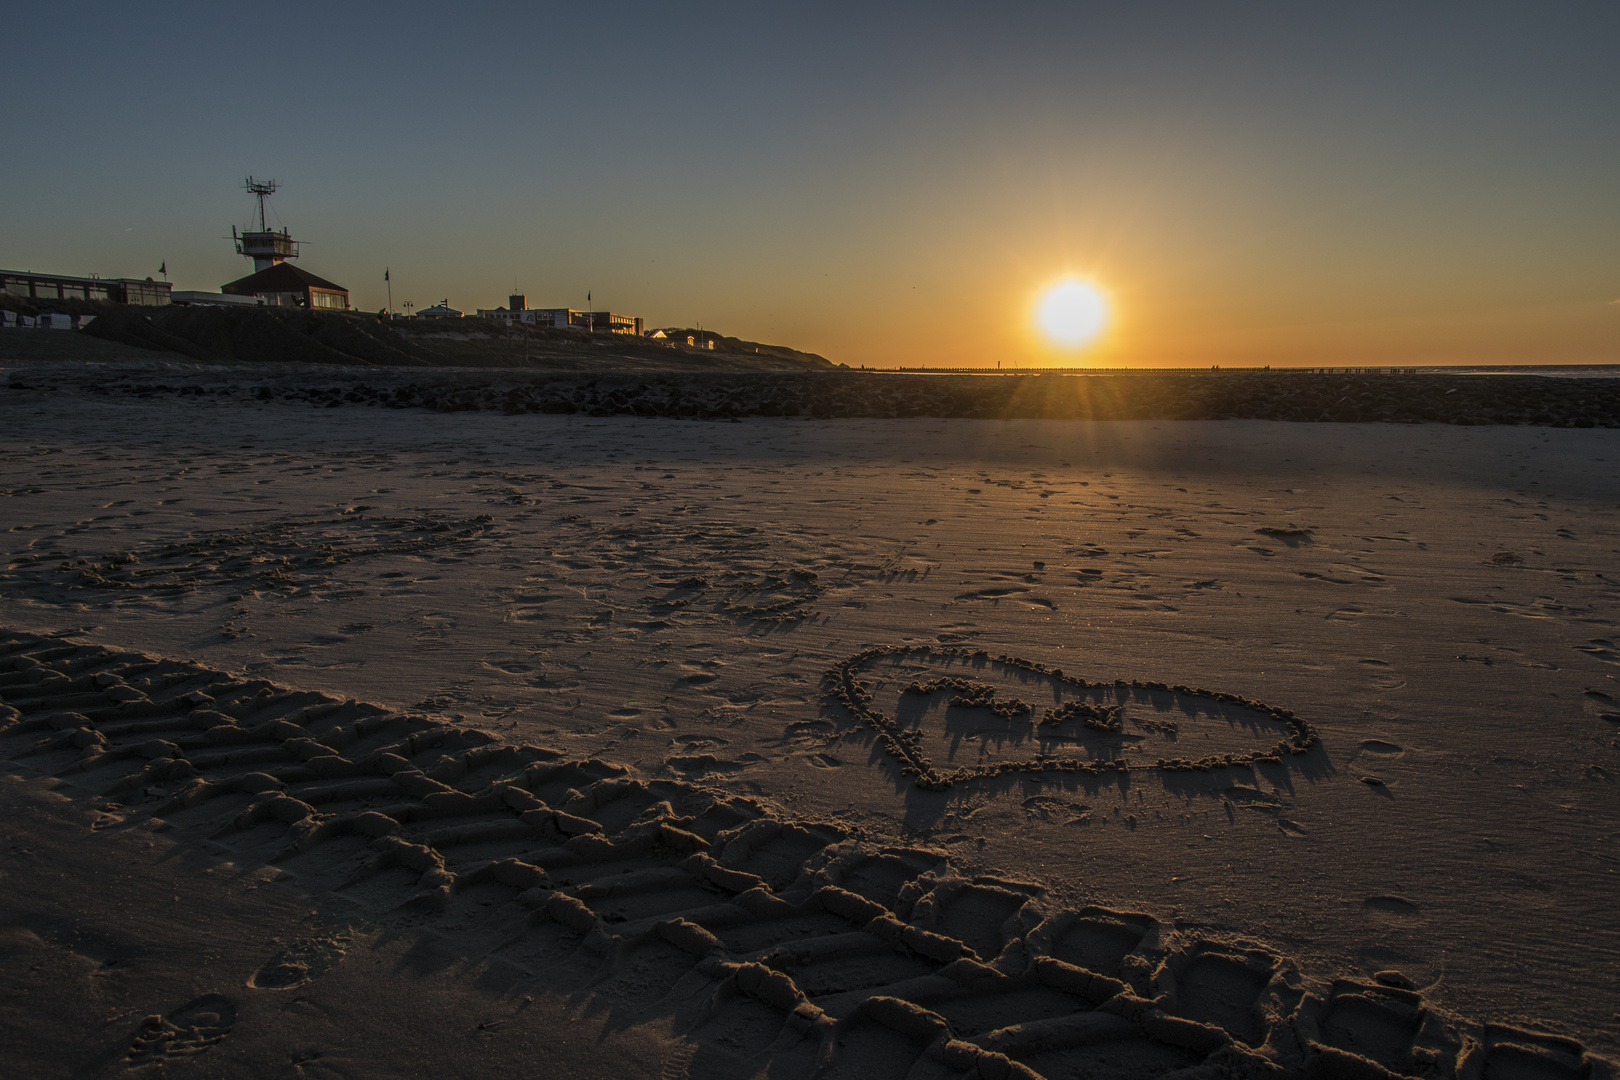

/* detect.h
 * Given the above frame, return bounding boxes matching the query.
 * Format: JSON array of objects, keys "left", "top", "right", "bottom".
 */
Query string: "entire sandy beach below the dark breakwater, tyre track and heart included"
[{"left": 0, "top": 371, "right": 1620, "bottom": 1078}]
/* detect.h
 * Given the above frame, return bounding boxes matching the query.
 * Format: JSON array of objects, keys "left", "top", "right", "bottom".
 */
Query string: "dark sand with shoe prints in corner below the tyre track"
[{"left": 0, "top": 777, "right": 671, "bottom": 1080}]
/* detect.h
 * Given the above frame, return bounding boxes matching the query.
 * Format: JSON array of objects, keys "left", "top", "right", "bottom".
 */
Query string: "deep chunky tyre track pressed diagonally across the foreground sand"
[{"left": 0, "top": 631, "right": 1614, "bottom": 1078}]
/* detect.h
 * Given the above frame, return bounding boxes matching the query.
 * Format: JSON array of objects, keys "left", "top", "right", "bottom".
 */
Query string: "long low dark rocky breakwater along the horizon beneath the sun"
[{"left": 44, "top": 369, "right": 1620, "bottom": 427}]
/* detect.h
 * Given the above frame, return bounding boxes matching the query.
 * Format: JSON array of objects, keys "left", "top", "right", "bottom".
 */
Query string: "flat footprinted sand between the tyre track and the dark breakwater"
[{"left": 0, "top": 367, "right": 1620, "bottom": 1075}]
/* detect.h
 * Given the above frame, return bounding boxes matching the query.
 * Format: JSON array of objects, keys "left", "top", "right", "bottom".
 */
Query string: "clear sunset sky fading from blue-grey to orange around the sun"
[{"left": 0, "top": 0, "right": 1620, "bottom": 369}]
